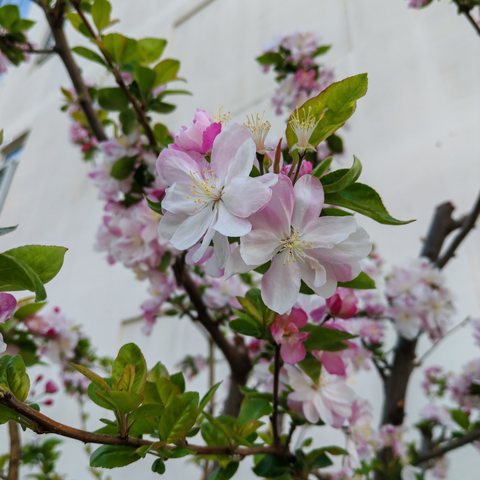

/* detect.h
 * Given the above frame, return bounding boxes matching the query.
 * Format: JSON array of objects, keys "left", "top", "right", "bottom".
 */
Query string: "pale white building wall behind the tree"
[{"left": 0, "top": 0, "right": 480, "bottom": 480}]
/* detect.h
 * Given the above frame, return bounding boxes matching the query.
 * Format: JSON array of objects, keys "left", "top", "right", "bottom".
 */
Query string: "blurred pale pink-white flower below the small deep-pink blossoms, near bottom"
[{"left": 285, "top": 365, "right": 354, "bottom": 428}]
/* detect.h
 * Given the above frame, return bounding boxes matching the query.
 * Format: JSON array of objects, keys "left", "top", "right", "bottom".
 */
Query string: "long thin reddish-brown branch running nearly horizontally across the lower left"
[{"left": 0, "top": 391, "right": 284, "bottom": 457}]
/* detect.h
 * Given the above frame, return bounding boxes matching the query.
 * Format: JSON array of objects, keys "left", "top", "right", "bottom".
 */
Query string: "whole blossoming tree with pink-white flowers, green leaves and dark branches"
[{"left": 0, "top": 0, "right": 480, "bottom": 480}]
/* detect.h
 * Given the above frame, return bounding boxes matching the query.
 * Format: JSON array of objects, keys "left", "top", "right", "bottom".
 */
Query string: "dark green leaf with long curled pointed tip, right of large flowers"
[{"left": 325, "top": 183, "right": 414, "bottom": 225}]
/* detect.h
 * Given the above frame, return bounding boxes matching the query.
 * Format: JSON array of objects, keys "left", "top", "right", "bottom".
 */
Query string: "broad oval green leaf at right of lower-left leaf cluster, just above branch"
[{"left": 159, "top": 392, "right": 199, "bottom": 443}]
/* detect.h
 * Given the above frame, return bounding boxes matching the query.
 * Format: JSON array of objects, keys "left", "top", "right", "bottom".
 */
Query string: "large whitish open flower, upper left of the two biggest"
[{"left": 157, "top": 120, "right": 272, "bottom": 261}]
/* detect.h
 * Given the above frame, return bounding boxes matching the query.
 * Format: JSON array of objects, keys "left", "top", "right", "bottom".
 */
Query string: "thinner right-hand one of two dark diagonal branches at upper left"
[{"left": 71, "top": 0, "right": 157, "bottom": 148}]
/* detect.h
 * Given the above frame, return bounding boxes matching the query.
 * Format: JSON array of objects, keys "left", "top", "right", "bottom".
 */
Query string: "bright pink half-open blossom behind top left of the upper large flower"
[{"left": 173, "top": 109, "right": 222, "bottom": 155}]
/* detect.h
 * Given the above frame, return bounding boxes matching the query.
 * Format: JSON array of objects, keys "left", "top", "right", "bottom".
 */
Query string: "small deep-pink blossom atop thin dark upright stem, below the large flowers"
[{"left": 270, "top": 308, "right": 310, "bottom": 365}]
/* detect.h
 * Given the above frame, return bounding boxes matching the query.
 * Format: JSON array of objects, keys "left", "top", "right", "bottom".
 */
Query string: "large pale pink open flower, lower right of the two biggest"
[{"left": 240, "top": 175, "right": 371, "bottom": 314}]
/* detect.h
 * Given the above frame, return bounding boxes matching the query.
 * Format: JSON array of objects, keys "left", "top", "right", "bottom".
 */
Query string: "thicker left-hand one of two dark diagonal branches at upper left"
[{"left": 37, "top": 1, "right": 107, "bottom": 142}]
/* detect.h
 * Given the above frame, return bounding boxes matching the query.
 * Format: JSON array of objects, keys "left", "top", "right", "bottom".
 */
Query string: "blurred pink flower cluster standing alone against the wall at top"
[{"left": 257, "top": 32, "right": 334, "bottom": 115}]
